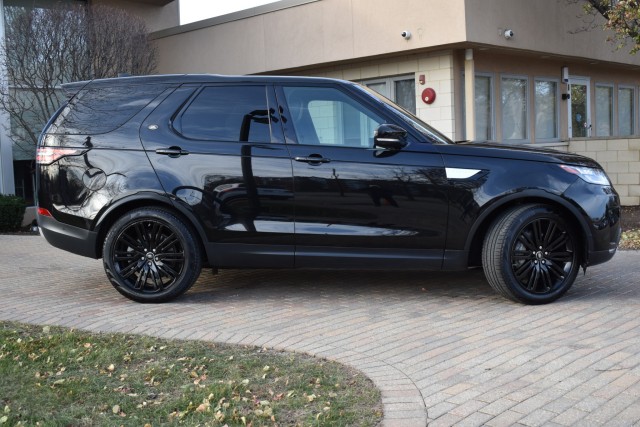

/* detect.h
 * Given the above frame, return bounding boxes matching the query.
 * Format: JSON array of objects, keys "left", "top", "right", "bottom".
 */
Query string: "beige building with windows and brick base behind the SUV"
[{"left": 152, "top": 0, "right": 640, "bottom": 205}]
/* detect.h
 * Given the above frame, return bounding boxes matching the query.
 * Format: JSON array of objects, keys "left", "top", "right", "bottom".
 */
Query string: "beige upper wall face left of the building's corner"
[{"left": 155, "top": 0, "right": 465, "bottom": 74}]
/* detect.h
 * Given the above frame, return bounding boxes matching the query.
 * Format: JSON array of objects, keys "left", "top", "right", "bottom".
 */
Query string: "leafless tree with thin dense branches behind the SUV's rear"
[{"left": 0, "top": 3, "right": 156, "bottom": 158}]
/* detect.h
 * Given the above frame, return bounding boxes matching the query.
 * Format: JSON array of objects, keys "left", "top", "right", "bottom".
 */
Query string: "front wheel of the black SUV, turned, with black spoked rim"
[{"left": 482, "top": 204, "right": 580, "bottom": 304}]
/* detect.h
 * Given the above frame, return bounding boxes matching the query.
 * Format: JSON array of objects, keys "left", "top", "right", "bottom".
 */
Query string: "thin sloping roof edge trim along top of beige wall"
[{"left": 149, "top": 0, "right": 320, "bottom": 40}]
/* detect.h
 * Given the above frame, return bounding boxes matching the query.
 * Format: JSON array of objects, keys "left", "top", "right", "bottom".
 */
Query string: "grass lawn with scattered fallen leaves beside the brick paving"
[{"left": 0, "top": 322, "right": 382, "bottom": 427}]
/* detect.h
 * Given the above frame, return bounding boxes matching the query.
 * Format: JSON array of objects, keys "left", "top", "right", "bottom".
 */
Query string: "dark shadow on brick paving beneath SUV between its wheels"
[{"left": 176, "top": 269, "right": 506, "bottom": 303}]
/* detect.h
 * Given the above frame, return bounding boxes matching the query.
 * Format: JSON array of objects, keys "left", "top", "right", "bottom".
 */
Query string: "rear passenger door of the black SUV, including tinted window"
[{"left": 140, "top": 83, "right": 294, "bottom": 267}]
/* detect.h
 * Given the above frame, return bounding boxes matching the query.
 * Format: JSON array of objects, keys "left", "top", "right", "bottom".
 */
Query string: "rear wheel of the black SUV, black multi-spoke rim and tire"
[{"left": 102, "top": 208, "right": 202, "bottom": 303}]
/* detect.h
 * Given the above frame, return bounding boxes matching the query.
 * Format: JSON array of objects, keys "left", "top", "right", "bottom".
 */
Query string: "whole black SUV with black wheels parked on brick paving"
[{"left": 37, "top": 75, "right": 620, "bottom": 304}]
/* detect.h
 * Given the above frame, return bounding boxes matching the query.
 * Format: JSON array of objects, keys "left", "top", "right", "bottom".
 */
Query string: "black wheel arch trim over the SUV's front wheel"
[{"left": 465, "top": 190, "right": 593, "bottom": 266}]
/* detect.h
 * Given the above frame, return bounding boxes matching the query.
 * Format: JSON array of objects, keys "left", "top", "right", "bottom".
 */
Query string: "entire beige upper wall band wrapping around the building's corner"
[{"left": 154, "top": 0, "right": 640, "bottom": 74}]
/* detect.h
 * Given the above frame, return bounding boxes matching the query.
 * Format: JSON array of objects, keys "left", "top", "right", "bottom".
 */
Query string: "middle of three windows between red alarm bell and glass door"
[{"left": 501, "top": 77, "right": 529, "bottom": 142}]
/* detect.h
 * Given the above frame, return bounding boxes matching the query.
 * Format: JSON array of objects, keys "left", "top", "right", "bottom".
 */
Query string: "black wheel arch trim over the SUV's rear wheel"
[{"left": 95, "top": 193, "right": 207, "bottom": 260}]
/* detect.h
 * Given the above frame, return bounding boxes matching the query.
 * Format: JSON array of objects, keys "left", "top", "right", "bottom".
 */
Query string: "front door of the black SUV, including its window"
[{"left": 278, "top": 85, "right": 448, "bottom": 268}]
